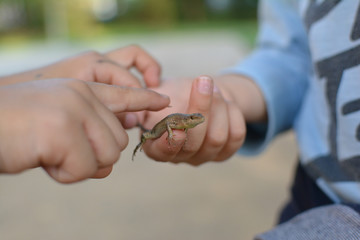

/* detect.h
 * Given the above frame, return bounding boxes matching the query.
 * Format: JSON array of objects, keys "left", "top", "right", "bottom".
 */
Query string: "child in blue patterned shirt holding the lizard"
[{"left": 139, "top": 0, "right": 360, "bottom": 239}]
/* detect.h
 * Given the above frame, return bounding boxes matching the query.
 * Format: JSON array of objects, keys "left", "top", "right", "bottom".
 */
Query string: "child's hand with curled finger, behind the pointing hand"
[{"left": 0, "top": 45, "right": 161, "bottom": 87}]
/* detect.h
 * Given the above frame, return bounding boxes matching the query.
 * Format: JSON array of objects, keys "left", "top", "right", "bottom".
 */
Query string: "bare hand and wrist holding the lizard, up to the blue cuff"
[{"left": 138, "top": 75, "right": 267, "bottom": 166}]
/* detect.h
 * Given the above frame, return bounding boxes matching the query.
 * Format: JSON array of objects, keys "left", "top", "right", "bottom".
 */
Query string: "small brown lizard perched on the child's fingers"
[{"left": 132, "top": 113, "right": 205, "bottom": 160}]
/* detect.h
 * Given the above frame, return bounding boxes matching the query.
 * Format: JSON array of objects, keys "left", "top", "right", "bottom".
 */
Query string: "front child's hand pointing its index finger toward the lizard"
[{"left": 0, "top": 79, "right": 169, "bottom": 183}]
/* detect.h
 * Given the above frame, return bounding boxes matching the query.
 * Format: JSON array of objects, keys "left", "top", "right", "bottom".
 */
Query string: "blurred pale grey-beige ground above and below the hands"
[{"left": 0, "top": 32, "right": 296, "bottom": 240}]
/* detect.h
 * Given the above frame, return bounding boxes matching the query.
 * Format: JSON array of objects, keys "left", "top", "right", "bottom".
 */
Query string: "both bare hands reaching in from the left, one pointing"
[{"left": 0, "top": 45, "right": 169, "bottom": 183}]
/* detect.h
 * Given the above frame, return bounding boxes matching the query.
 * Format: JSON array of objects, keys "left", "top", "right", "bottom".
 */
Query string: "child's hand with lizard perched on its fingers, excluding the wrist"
[{"left": 139, "top": 76, "right": 246, "bottom": 165}]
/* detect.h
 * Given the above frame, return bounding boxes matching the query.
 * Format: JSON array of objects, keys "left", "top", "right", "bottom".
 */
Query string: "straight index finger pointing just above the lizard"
[{"left": 87, "top": 82, "right": 170, "bottom": 113}]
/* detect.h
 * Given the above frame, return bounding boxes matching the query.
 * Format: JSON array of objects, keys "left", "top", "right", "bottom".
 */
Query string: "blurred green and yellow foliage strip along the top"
[{"left": 0, "top": 0, "right": 257, "bottom": 41}]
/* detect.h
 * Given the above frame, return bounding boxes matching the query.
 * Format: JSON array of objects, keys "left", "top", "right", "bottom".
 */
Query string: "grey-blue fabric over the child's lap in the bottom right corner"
[{"left": 255, "top": 205, "right": 360, "bottom": 240}]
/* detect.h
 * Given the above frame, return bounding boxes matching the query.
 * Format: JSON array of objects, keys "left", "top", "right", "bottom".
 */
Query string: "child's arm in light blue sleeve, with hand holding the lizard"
[{"left": 136, "top": 0, "right": 312, "bottom": 165}]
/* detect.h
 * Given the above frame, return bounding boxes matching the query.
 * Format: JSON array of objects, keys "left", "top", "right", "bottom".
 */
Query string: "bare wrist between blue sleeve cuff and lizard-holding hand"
[{"left": 215, "top": 74, "right": 267, "bottom": 123}]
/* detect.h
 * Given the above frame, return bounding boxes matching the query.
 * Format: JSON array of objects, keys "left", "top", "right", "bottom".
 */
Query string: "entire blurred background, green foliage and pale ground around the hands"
[{"left": 0, "top": 0, "right": 296, "bottom": 240}]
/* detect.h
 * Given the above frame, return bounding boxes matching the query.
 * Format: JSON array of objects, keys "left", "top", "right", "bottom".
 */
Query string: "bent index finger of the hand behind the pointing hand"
[{"left": 106, "top": 45, "right": 161, "bottom": 87}]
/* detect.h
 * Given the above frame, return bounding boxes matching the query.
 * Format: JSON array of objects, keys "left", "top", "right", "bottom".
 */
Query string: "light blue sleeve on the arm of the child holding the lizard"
[{"left": 225, "top": 0, "right": 312, "bottom": 155}]
